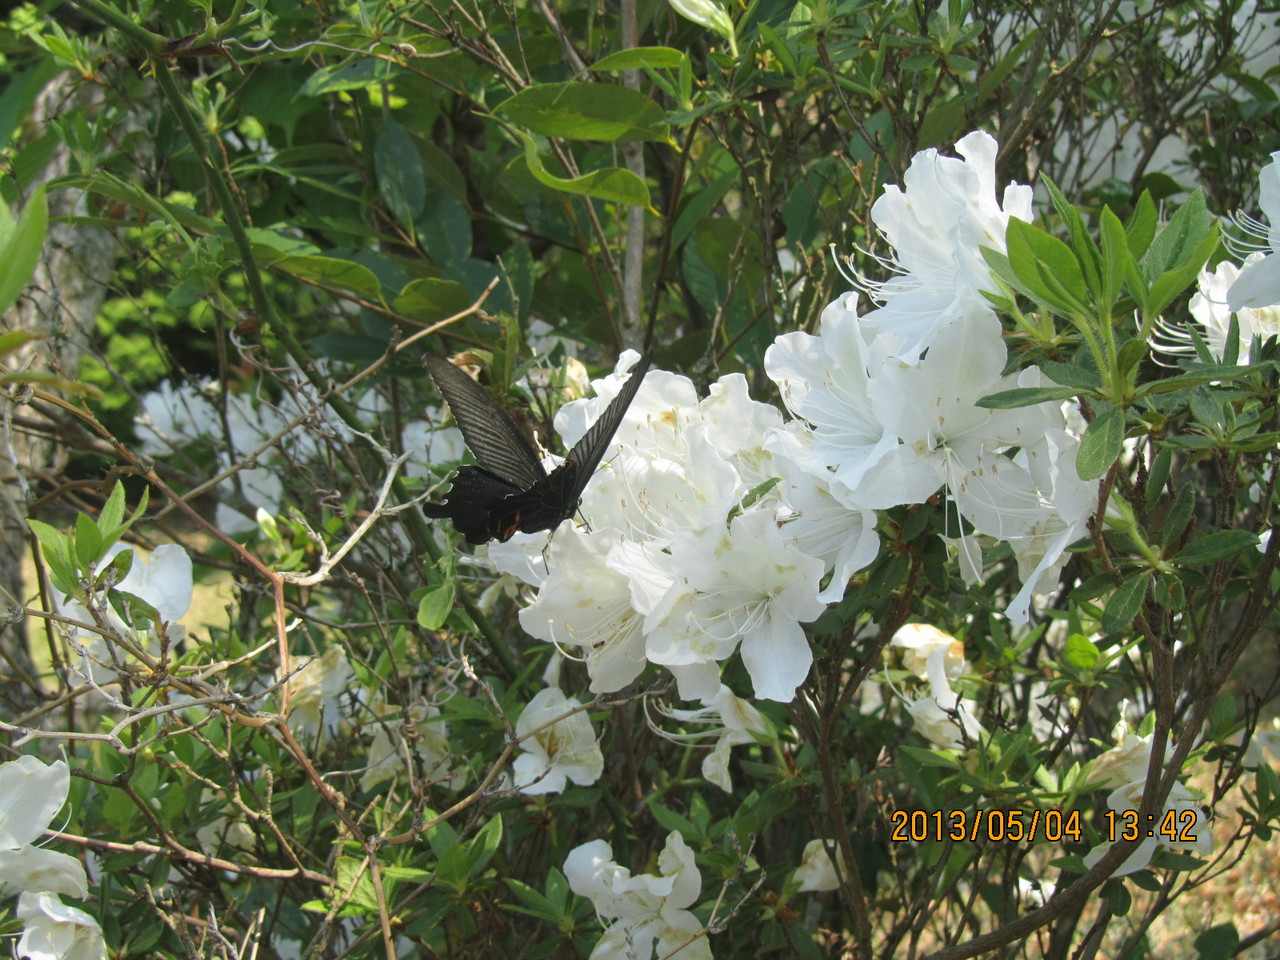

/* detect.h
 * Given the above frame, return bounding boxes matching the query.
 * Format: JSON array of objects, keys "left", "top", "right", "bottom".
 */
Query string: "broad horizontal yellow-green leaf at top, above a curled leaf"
[{"left": 498, "top": 82, "right": 668, "bottom": 143}]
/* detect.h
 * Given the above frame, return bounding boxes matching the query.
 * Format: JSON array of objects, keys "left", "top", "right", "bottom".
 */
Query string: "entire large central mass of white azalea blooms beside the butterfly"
[{"left": 489, "top": 133, "right": 1097, "bottom": 716}]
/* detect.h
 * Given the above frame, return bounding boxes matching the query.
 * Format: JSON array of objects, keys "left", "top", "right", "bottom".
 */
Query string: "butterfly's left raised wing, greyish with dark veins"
[{"left": 426, "top": 355, "right": 547, "bottom": 492}]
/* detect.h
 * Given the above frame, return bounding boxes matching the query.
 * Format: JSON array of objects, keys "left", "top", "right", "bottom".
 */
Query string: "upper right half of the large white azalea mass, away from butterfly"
[{"left": 764, "top": 133, "right": 1097, "bottom": 622}]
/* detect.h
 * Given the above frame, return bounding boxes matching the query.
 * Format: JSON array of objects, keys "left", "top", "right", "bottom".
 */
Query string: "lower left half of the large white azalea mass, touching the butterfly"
[{"left": 489, "top": 352, "right": 829, "bottom": 700}]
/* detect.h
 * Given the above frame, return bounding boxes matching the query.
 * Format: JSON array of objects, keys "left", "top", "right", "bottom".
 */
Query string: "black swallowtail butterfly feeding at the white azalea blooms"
[{"left": 422, "top": 353, "right": 653, "bottom": 544}]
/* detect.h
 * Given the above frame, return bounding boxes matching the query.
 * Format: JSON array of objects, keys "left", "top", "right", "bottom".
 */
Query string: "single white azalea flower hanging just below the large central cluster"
[{"left": 512, "top": 687, "right": 604, "bottom": 794}]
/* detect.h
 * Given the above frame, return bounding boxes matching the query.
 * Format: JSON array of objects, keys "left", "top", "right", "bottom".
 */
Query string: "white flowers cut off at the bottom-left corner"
[{"left": 0, "top": 756, "right": 106, "bottom": 960}]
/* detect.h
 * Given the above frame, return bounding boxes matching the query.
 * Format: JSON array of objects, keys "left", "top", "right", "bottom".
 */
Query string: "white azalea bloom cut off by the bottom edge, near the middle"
[{"left": 564, "top": 831, "right": 712, "bottom": 960}]
